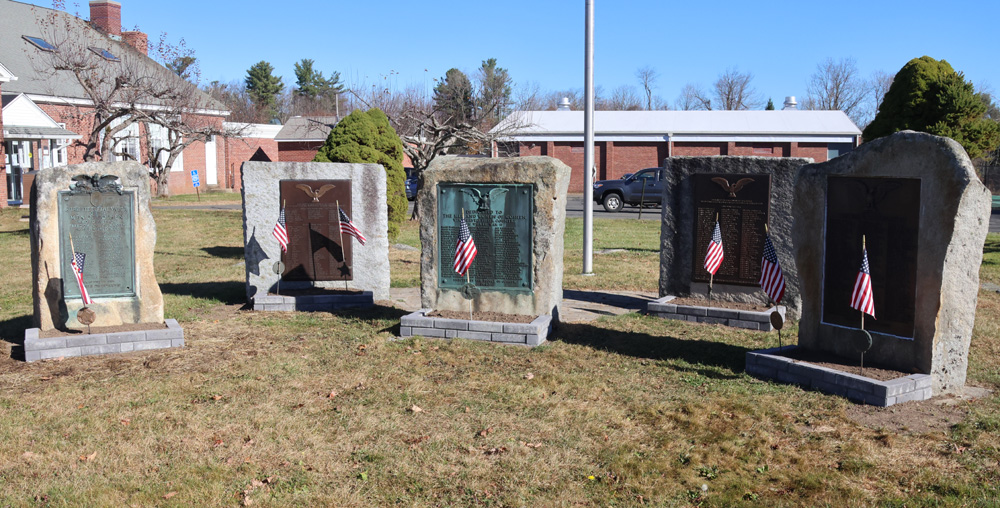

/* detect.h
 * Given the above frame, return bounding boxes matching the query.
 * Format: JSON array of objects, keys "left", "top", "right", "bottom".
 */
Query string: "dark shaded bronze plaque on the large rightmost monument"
[{"left": 823, "top": 176, "right": 920, "bottom": 338}]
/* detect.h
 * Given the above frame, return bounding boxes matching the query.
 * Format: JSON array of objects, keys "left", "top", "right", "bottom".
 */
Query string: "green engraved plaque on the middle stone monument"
[{"left": 438, "top": 183, "right": 535, "bottom": 292}]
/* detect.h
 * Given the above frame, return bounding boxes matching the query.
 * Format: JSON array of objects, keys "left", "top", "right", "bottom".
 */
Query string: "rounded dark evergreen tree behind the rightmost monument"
[{"left": 863, "top": 56, "right": 1000, "bottom": 159}]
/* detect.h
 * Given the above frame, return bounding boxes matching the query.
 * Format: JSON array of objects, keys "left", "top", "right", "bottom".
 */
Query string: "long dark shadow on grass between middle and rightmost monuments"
[{"left": 549, "top": 323, "right": 750, "bottom": 373}]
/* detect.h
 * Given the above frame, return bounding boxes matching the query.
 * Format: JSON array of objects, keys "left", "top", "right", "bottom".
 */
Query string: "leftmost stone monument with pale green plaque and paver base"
[{"left": 24, "top": 162, "right": 184, "bottom": 361}]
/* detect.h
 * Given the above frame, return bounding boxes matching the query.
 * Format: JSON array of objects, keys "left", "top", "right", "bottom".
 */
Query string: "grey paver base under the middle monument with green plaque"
[{"left": 399, "top": 309, "right": 552, "bottom": 346}]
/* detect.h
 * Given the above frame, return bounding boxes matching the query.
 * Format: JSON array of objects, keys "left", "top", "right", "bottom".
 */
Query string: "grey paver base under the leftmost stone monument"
[{"left": 24, "top": 319, "right": 184, "bottom": 362}]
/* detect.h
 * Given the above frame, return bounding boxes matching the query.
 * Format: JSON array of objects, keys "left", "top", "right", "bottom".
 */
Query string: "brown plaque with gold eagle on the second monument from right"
[{"left": 691, "top": 173, "right": 771, "bottom": 286}]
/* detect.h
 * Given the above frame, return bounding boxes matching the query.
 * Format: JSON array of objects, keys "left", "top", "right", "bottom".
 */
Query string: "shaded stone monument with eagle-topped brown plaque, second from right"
[{"left": 648, "top": 157, "right": 812, "bottom": 330}]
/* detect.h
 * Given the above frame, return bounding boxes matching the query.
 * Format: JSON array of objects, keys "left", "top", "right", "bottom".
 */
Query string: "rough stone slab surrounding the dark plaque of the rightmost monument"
[{"left": 793, "top": 131, "right": 990, "bottom": 393}]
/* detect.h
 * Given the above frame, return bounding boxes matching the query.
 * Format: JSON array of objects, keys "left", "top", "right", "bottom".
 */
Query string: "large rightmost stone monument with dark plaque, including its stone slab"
[{"left": 747, "top": 131, "right": 990, "bottom": 405}]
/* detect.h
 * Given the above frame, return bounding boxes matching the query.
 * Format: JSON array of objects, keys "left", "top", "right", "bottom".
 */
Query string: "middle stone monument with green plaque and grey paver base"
[{"left": 400, "top": 157, "right": 570, "bottom": 345}]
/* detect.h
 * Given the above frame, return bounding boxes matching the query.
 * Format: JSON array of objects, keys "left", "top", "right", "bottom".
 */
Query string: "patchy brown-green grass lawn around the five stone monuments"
[{"left": 0, "top": 209, "right": 1000, "bottom": 507}]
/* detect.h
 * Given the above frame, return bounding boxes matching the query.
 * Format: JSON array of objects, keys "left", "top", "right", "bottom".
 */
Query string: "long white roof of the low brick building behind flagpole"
[{"left": 493, "top": 110, "right": 861, "bottom": 140}]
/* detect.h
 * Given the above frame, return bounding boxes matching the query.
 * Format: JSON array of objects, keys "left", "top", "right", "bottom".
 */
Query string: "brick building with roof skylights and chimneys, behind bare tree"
[{"left": 0, "top": 0, "right": 229, "bottom": 206}]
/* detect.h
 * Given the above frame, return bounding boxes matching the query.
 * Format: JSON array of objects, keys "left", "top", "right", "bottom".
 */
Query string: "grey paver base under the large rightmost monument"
[{"left": 746, "top": 346, "right": 933, "bottom": 407}]
